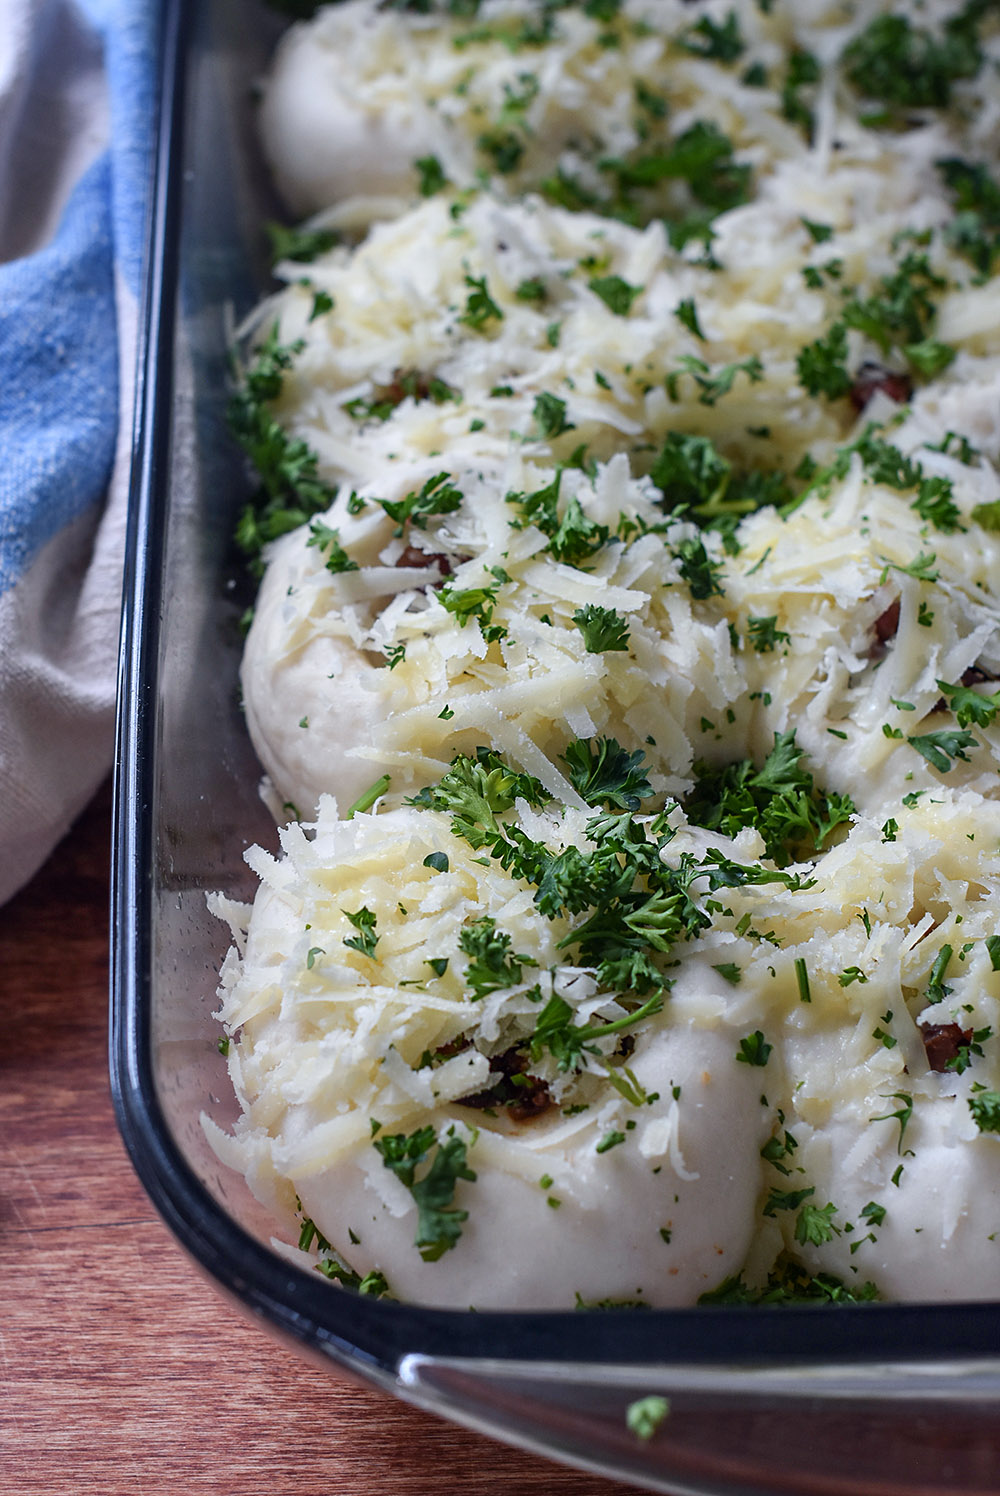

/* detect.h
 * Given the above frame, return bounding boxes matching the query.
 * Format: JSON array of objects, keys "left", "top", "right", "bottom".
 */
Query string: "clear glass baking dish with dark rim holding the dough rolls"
[{"left": 111, "top": 0, "right": 1000, "bottom": 1496}]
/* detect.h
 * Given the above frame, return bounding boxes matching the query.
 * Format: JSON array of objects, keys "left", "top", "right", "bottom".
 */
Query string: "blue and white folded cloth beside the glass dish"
[{"left": 0, "top": 0, "right": 159, "bottom": 902}]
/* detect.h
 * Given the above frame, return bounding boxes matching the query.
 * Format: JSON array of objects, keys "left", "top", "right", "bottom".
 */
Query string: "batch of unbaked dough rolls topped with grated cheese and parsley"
[{"left": 212, "top": 0, "right": 1000, "bottom": 1309}]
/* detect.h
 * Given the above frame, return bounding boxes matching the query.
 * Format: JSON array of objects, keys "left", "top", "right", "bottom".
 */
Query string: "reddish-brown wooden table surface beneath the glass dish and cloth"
[{"left": 0, "top": 788, "right": 637, "bottom": 1496}]
